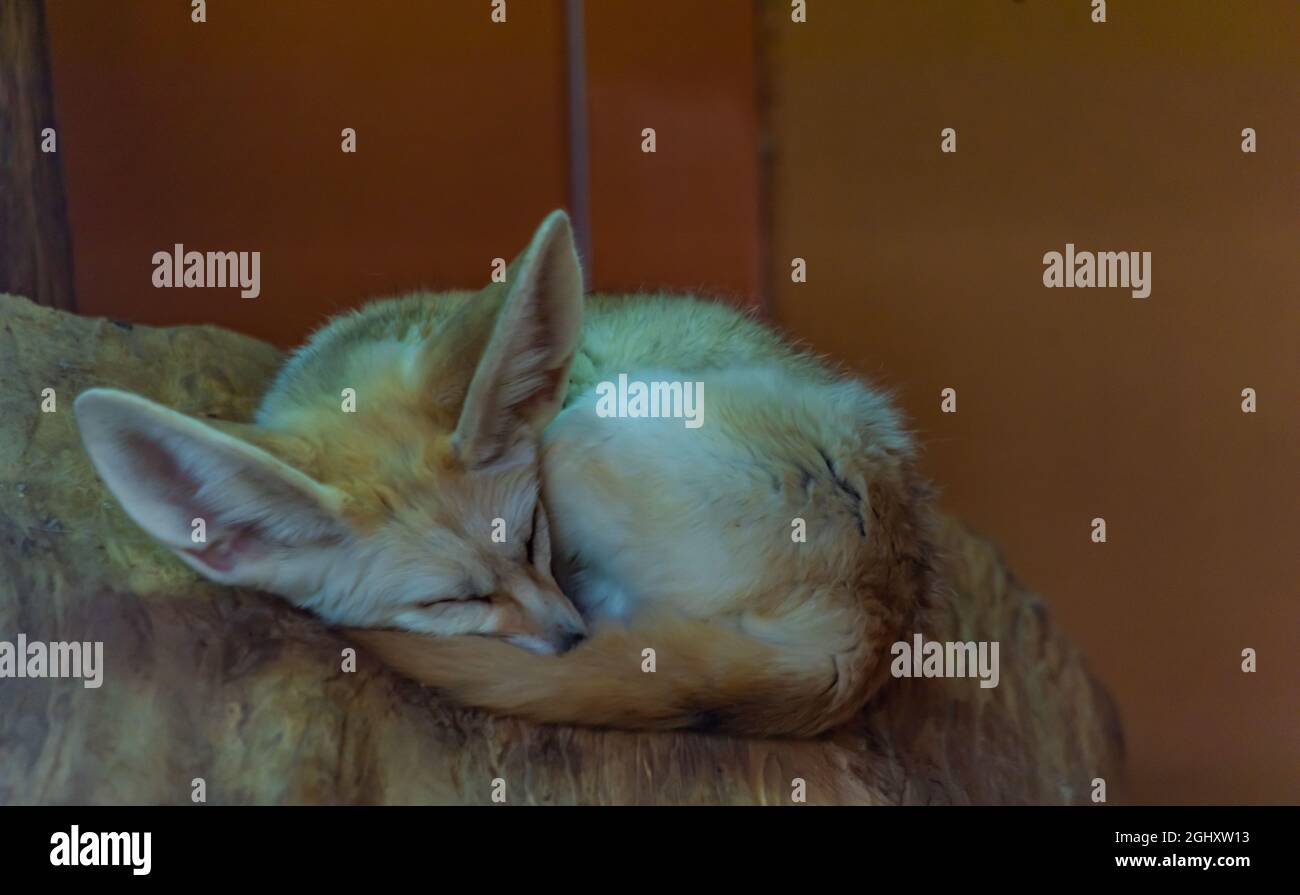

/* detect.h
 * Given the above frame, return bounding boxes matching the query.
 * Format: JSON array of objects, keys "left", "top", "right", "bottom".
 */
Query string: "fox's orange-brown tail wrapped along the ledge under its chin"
[{"left": 347, "top": 618, "right": 868, "bottom": 736}]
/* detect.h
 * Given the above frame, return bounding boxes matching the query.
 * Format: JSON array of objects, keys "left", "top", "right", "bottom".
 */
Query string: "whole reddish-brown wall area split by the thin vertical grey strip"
[{"left": 47, "top": 0, "right": 761, "bottom": 345}]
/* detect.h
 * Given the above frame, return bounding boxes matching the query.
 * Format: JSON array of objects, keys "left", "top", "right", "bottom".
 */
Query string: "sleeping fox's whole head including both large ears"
[{"left": 77, "top": 213, "right": 585, "bottom": 652}]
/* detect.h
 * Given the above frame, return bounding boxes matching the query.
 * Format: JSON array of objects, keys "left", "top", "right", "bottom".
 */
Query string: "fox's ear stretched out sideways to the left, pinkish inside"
[{"left": 74, "top": 389, "right": 348, "bottom": 587}]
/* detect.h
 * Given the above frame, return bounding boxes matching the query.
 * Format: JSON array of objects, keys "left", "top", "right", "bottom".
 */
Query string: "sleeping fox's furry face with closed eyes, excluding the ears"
[{"left": 310, "top": 429, "right": 585, "bottom": 652}]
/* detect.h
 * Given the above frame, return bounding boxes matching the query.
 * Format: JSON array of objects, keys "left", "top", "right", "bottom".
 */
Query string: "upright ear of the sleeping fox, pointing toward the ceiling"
[{"left": 452, "top": 211, "right": 582, "bottom": 468}]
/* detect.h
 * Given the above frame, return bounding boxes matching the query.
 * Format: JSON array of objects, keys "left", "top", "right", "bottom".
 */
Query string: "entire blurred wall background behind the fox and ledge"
[{"left": 0, "top": 0, "right": 1300, "bottom": 803}]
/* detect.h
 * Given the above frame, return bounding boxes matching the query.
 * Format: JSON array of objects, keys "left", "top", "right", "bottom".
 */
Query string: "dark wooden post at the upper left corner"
[{"left": 0, "top": 0, "right": 75, "bottom": 310}]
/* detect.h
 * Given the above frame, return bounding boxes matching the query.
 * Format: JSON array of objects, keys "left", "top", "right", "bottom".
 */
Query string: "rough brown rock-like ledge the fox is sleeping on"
[{"left": 0, "top": 295, "right": 1122, "bottom": 804}]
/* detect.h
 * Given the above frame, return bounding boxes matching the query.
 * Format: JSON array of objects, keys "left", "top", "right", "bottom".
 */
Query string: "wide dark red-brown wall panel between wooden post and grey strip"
[{"left": 47, "top": 0, "right": 568, "bottom": 342}]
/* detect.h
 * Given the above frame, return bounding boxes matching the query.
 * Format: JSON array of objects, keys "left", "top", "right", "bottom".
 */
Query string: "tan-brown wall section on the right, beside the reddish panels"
[{"left": 763, "top": 0, "right": 1300, "bottom": 803}]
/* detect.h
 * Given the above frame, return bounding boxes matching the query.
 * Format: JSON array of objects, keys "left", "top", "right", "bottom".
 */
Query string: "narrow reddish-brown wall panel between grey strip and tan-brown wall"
[{"left": 585, "top": 0, "right": 762, "bottom": 303}]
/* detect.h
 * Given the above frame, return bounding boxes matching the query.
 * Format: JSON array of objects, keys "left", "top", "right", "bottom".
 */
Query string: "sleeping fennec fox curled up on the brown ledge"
[{"left": 77, "top": 212, "right": 931, "bottom": 735}]
